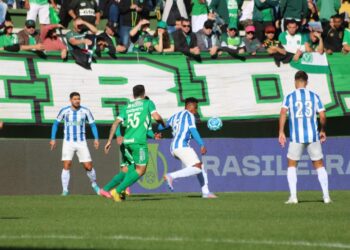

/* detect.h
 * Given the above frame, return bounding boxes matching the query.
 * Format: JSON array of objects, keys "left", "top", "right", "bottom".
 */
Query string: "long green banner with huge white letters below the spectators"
[{"left": 0, "top": 53, "right": 350, "bottom": 125}]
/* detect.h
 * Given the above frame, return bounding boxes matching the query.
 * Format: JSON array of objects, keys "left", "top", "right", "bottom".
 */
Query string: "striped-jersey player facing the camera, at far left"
[{"left": 50, "top": 92, "right": 99, "bottom": 196}]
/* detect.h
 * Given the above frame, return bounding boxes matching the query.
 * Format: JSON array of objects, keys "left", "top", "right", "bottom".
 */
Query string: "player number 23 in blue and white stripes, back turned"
[{"left": 279, "top": 71, "right": 331, "bottom": 204}]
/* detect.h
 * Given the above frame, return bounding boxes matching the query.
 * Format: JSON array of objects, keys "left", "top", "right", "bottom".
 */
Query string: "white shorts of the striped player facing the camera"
[{"left": 62, "top": 141, "right": 92, "bottom": 163}]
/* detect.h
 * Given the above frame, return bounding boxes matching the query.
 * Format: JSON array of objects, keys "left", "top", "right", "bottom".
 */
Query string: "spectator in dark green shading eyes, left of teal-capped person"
[{"left": 128, "top": 19, "right": 152, "bottom": 52}]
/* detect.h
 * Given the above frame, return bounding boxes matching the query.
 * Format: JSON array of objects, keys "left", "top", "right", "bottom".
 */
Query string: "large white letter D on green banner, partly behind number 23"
[{"left": 194, "top": 62, "right": 331, "bottom": 117}]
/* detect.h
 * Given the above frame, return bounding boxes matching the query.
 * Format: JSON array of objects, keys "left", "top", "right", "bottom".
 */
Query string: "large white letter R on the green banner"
[{"left": 38, "top": 62, "right": 179, "bottom": 121}]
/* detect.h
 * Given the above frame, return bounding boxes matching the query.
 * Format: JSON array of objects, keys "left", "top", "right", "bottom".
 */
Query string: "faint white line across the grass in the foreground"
[{"left": 0, "top": 235, "right": 350, "bottom": 249}]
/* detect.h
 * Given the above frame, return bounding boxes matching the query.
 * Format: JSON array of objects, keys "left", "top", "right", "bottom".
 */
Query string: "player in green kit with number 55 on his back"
[{"left": 105, "top": 85, "right": 165, "bottom": 202}]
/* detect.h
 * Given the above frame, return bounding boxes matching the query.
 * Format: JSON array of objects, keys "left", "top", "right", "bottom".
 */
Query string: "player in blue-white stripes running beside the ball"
[{"left": 158, "top": 97, "right": 216, "bottom": 198}]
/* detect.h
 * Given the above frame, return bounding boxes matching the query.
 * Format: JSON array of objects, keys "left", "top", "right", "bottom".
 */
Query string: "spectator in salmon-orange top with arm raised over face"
[{"left": 40, "top": 24, "right": 67, "bottom": 59}]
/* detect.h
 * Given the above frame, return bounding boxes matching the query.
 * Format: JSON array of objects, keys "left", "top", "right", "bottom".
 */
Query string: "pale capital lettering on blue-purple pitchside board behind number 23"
[{"left": 202, "top": 155, "right": 350, "bottom": 177}]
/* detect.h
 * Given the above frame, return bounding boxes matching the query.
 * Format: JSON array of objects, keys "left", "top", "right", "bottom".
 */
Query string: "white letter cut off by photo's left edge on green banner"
[{"left": 0, "top": 60, "right": 33, "bottom": 120}]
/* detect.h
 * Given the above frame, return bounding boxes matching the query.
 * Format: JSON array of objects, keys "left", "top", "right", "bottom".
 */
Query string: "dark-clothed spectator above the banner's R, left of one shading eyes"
[{"left": 96, "top": 22, "right": 126, "bottom": 58}]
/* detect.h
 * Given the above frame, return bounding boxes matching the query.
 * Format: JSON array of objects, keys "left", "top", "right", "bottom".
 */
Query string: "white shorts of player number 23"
[{"left": 287, "top": 141, "right": 323, "bottom": 161}]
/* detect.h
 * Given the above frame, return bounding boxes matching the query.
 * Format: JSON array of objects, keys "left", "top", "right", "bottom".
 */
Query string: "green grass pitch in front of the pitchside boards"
[{"left": 0, "top": 191, "right": 350, "bottom": 250}]
